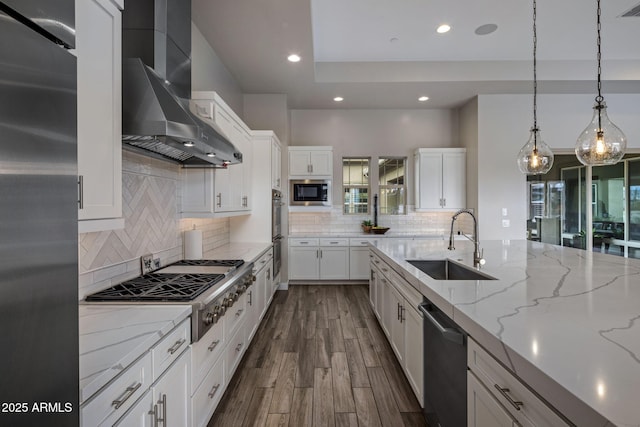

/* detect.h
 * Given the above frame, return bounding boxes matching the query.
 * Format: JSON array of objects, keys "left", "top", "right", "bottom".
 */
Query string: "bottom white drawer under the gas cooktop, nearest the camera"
[{"left": 191, "top": 357, "right": 226, "bottom": 427}]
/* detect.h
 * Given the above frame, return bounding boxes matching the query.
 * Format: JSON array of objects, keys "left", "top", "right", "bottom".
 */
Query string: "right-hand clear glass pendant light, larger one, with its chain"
[{"left": 575, "top": 0, "right": 627, "bottom": 166}]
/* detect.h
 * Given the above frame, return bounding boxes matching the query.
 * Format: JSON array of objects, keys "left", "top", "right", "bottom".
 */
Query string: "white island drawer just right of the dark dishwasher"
[{"left": 467, "top": 339, "right": 569, "bottom": 427}]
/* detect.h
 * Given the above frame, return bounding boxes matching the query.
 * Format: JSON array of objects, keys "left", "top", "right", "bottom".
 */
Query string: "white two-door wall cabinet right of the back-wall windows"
[{"left": 414, "top": 148, "right": 467, "bottom": 211}]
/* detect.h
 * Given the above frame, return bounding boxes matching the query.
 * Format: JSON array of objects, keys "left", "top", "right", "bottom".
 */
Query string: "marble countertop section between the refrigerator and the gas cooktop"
[{"left": 79, "top": 304, "right": 191, "bottom": 402}]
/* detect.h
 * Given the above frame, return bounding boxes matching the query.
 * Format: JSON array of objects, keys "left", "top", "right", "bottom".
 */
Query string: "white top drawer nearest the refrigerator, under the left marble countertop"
[{"left": 80, "top": 353, "right": 153, "bottom": 427}]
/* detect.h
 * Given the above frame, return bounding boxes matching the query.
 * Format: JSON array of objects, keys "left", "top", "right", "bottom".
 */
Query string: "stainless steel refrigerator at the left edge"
[{"left": 0, "top": 0, "right": 79, "bottom": 426}]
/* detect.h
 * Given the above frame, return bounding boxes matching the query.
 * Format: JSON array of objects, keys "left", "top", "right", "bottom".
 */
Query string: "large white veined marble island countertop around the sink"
[{"left": 374, "top": 239, "right": 640, "bottom": 427}]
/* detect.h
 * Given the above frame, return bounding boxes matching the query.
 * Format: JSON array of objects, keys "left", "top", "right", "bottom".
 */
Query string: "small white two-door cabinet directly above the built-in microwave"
[{"left": 289, "top": 146, "right": 333, "bottom": 179}]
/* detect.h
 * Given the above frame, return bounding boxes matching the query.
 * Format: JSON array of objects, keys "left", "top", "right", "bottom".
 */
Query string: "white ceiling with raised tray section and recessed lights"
[{"left": 192, "top": 0, "right": 640, "bottom": 109}]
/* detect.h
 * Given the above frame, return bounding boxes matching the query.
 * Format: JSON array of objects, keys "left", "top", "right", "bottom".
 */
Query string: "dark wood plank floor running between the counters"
[{"left": 209, "top": 285, "right": 426, "bottom": 427}]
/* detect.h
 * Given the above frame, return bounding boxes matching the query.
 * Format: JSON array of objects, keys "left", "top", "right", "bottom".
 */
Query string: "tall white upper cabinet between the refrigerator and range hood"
[{"left": 76, "top": 0, "right": 124, "bottom": 232}]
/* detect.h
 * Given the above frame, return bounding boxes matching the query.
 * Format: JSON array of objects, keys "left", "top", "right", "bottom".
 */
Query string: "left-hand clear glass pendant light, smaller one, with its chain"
[{"left": 516, "top": 0, "right": 553, "bottom": 175}]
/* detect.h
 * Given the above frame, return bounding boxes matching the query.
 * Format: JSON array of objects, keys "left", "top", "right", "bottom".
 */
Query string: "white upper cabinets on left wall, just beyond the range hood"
[{"left": 182, "top": 92, "right": 253, "bottom": 217}]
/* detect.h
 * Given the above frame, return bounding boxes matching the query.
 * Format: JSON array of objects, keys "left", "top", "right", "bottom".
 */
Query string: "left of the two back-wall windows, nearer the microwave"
[{"left": 342, "top": 157, "right": 370, "bottom": 214}]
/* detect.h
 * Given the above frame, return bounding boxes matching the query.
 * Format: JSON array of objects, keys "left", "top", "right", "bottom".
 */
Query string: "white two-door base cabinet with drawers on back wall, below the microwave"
[{"left": 289, "top": 238, "right": 349, "bottom": 280}]
